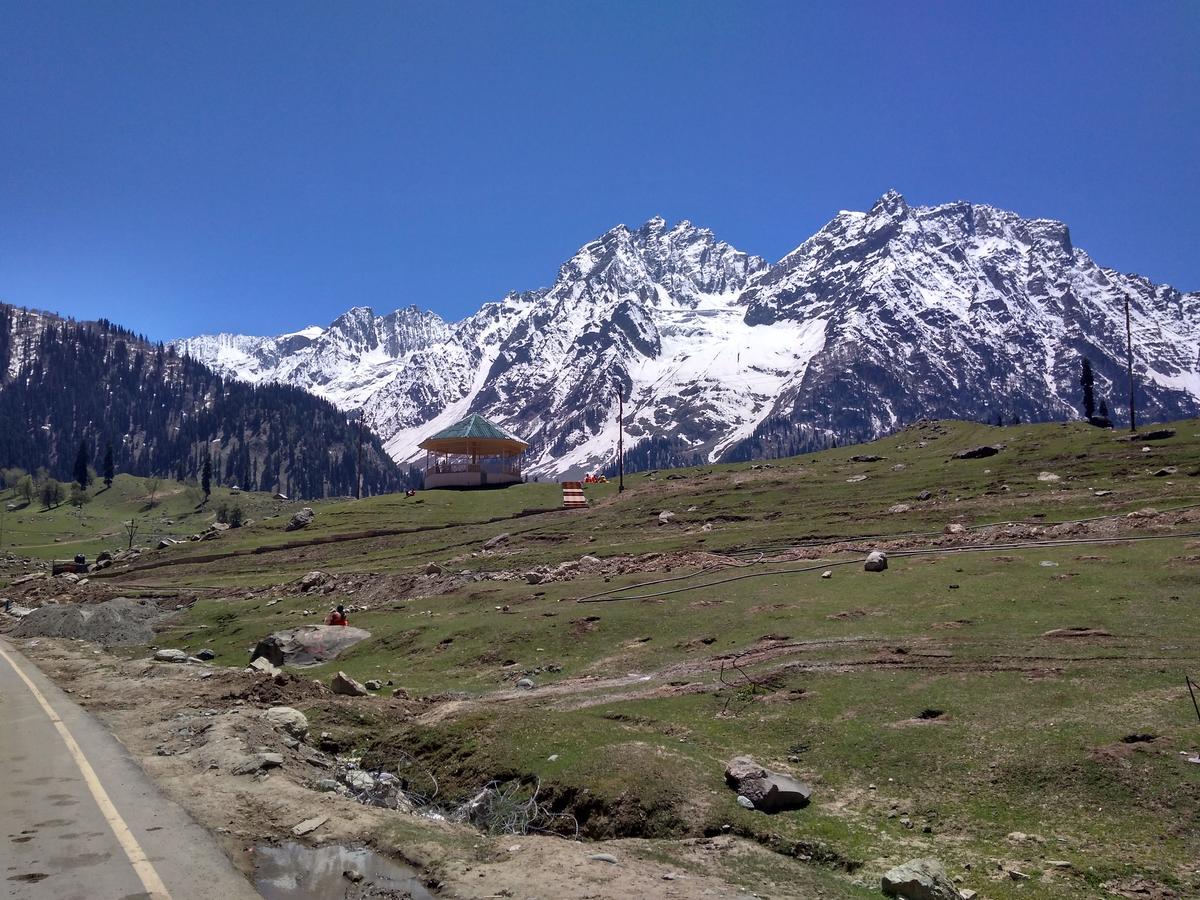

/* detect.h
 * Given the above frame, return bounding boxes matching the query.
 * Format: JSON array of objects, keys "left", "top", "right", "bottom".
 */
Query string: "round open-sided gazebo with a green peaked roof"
[{"left": 418, "top": 413, "right": 529, "bottom": 488}]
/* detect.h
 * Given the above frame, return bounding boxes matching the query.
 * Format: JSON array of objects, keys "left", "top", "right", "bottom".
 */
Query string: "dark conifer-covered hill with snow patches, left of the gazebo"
[{"left": 0, "top": 304, "right": 406, "bottom": 497}]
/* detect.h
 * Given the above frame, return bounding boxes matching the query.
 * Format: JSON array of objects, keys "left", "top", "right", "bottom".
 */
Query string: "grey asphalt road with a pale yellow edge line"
[{"left": 0, "top": 640, "right": 259, "bottom": 900}]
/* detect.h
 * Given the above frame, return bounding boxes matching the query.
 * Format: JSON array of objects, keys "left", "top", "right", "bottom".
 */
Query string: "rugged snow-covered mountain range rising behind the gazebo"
[{"left": 178, "top": 192, "right": 1200, "bottom": 475}]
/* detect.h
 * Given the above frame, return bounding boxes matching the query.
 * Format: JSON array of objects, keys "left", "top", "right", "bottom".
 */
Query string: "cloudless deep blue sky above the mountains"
[{"left": 0, "top": 0, "right": 1200, "bottom": 338}]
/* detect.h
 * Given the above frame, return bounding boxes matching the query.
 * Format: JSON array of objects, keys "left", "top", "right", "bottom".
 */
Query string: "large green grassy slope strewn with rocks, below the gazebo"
[{"left": 14, "top": 420, "right": 1200, "bottom": 899}]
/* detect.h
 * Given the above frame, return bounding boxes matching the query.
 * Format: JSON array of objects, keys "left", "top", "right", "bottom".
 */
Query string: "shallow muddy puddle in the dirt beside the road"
[{"left": 254, "top": 841, "right": 434, "bottom": 900}]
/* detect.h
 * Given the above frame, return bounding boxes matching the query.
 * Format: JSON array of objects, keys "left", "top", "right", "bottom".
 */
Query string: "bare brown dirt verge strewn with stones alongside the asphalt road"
[{"left": 11, "top": 638, "right": 811, "bottom": 900}]
